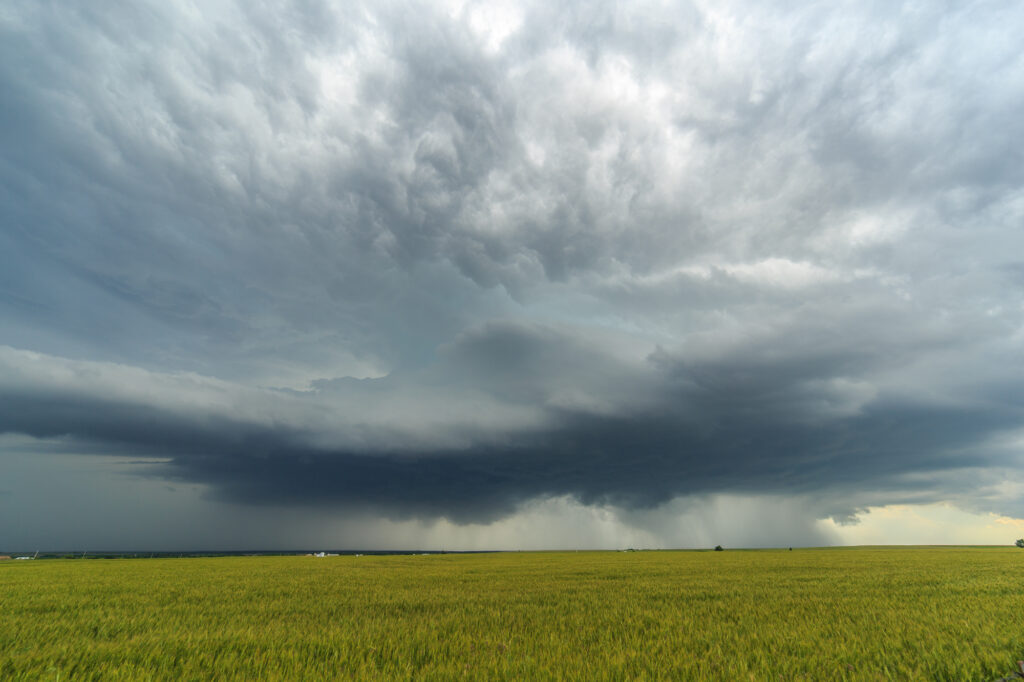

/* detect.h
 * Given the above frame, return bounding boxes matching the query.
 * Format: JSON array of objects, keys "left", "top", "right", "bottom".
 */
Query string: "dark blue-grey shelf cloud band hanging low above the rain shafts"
[{"left": 0, "top": 307, "right": 1024, "bottom": 521}]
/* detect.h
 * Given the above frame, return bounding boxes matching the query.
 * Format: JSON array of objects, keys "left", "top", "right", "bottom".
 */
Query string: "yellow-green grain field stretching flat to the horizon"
[{"left": 0, "top": 548, "right": 1024, "bottom": 681}]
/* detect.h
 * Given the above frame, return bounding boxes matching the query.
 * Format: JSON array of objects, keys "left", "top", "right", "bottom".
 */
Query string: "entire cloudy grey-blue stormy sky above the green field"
[{"left": 0, "top": 0, "right": 1024, "bottom": 551}]
